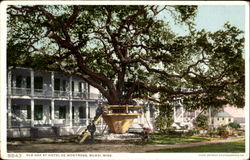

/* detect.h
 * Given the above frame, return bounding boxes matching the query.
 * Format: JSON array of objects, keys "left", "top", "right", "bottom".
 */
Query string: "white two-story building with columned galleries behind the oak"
[{"left": 7, "top": 67, "right": 154, "bottom": 137}]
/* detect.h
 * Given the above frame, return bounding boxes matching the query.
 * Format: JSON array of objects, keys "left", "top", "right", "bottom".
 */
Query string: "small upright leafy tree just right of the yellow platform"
[{"left": 156, "top": 104, "right": 174, "bottom": 132}]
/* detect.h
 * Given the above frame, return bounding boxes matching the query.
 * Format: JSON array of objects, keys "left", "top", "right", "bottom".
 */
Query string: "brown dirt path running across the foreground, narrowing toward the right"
[{"left": 8, "top": 138, "right": 244, "bottom": 153}]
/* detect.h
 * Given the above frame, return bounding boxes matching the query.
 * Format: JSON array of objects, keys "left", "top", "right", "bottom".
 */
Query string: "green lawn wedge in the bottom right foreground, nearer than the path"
[{"left": 150, "top": 141, "right": 245, "bottom": 153}]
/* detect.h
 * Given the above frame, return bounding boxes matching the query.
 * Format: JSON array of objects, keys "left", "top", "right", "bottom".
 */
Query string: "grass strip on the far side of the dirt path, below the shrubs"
[{"left": 136, "top": 134, "right": 220, "bottom": 145}]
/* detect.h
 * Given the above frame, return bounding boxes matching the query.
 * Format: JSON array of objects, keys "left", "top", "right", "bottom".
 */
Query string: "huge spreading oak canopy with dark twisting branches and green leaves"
[{"left": 7, "top": 5, "right": 245, "bottom": 109}]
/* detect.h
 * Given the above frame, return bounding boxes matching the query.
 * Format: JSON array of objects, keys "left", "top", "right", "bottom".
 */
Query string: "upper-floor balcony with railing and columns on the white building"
[{"left": 7, "top": 68, "right": 104, "bottom": 99}]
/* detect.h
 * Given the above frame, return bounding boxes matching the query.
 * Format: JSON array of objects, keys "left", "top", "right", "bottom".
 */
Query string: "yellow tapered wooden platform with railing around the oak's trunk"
[{"left": 102, "top": 105, "right": 142, "bottom": 134}]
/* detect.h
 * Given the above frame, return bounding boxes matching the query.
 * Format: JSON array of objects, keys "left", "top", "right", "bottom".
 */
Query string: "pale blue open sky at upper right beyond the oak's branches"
[{"left": 165, "top": 5, "right": 245, "bottom": 35}]
